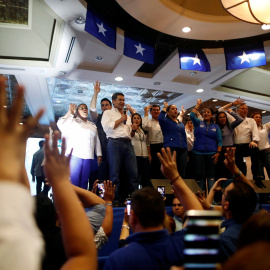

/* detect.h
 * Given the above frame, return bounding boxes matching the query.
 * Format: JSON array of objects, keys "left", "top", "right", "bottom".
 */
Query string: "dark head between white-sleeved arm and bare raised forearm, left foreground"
[{"left": 35, "top": 193, "right": 57, "bottom": 233}]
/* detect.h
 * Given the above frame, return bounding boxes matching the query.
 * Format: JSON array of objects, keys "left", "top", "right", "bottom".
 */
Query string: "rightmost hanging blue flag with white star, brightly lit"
[{"left": 224, "top": 42, "right": 266, "bottom": 70}]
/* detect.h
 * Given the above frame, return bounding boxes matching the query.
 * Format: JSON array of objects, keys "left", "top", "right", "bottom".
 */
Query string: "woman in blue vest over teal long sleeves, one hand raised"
[{"left": 190, "top": 99, "right": 222, "bottom": 190}]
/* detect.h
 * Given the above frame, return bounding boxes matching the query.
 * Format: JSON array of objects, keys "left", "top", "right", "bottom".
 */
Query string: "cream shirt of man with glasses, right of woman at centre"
[{"left": 142, "top": 116, "right": 163, "bottom": 144}]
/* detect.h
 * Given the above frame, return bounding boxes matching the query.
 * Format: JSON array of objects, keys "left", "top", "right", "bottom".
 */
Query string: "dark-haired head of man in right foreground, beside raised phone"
[{"left": 226, "top": 181, "right": 257, "bottom": 222}]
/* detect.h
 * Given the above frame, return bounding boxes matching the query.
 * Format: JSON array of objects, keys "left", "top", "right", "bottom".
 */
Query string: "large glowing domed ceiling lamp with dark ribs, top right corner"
[{"left": 220, "top": 0, "right": 270, "bottom": 24}]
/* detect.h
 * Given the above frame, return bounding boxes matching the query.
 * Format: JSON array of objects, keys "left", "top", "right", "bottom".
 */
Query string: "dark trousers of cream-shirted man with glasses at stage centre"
[{"left": 150, "top": 143, "right": 165, "bottom": 179}]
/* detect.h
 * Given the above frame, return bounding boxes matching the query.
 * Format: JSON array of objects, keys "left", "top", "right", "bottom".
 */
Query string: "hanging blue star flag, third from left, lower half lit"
[{"left": 178, "top": 48, "right": 211, "bottom": 72}]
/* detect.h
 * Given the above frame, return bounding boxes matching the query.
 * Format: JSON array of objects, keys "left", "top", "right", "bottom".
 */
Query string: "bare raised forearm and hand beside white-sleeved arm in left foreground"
[{"left": 45, "top": 131, "right": 97, "bottom": 270}]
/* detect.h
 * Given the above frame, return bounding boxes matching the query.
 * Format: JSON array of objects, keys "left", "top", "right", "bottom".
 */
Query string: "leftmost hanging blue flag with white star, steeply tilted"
[{"left": 85, "top": 5, "right": 116, "bottom": 49}]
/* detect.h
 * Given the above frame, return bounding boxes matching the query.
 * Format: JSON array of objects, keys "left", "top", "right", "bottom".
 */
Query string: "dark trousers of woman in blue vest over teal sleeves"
[{"left": 193, "top": 153, "right": 215, "bottom": 191}]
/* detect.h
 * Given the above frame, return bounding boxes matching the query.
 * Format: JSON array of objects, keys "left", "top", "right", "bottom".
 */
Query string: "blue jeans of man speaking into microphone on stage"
[{"left": 107, "top": 139, "right": 139, "bottom": 202}]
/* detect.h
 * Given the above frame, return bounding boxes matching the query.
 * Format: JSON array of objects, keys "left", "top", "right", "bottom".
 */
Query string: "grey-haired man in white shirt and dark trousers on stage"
[{"left": 231, "top": 103, "right": 262, "bottom": 185}]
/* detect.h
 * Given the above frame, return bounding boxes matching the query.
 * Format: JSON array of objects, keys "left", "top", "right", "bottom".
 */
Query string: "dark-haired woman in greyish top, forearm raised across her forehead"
[{"left": 215, "top": 98, "right": 244, "bottom": 180}]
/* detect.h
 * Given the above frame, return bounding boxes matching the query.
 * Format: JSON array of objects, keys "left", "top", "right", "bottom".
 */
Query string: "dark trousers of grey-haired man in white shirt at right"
[{"left": 235, "top": 143, "right": 260, "bottom": 179}]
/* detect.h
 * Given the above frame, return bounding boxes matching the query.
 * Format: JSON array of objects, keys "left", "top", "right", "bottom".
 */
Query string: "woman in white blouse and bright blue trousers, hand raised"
[{"left": 57, "top": 104, "right": 102, "bottom": 189}]
